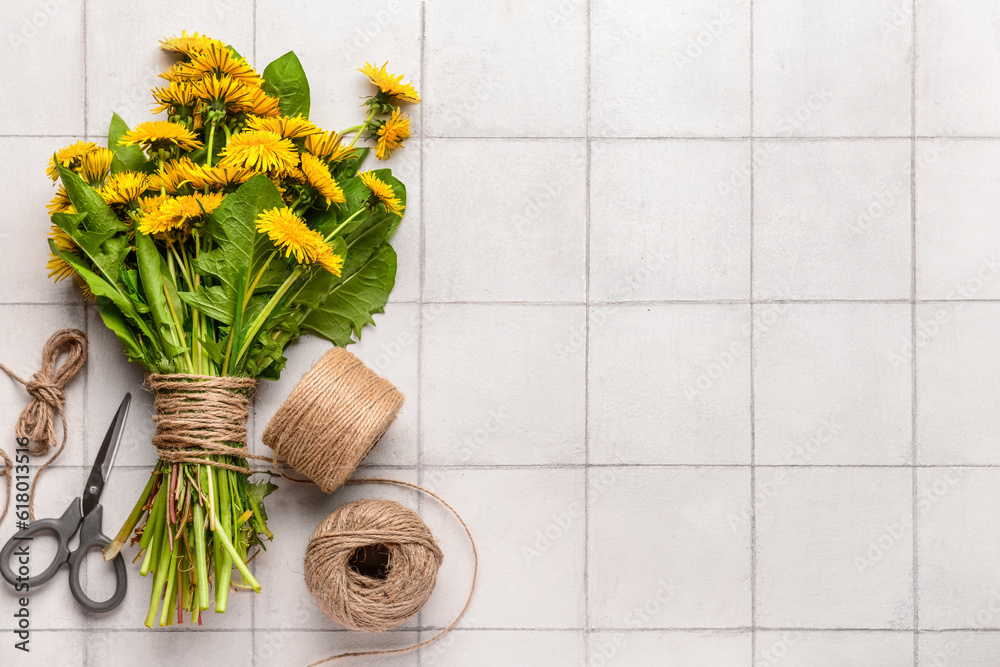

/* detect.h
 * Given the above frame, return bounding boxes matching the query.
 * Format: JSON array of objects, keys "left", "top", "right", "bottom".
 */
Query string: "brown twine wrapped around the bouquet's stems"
[{"left": 147, "top": 373, "right": 270, "bottom": 475}]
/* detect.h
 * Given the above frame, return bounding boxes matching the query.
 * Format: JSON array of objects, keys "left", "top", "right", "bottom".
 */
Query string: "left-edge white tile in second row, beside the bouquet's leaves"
[{"left": 0, "top": 137, "right": 83, "bottom": 304}]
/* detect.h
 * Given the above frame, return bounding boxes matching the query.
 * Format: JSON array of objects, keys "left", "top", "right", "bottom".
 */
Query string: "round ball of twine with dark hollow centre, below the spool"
[{"left": 305, "top": 500, "right": 444, "bottom": 632}]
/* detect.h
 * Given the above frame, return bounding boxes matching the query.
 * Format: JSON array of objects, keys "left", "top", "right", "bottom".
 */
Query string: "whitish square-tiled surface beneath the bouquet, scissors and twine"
[{"left": 0, "top": 0, "right": 1000, "bottom": 667}]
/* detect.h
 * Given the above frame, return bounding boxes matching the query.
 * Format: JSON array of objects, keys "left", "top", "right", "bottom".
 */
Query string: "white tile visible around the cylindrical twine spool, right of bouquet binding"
[{"left": 250, "top": 303, "right": 420, "bottom": 465}]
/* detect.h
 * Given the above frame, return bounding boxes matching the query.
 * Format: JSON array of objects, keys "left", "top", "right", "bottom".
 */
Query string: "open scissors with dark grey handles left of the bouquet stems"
[{"left": 0, "top": 394, "right": 132, "bottom": 612}]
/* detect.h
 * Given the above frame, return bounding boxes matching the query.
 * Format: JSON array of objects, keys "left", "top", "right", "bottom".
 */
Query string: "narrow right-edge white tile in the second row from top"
[{"left": 917, "top": 139, "right": 1000, "bottom": 299}]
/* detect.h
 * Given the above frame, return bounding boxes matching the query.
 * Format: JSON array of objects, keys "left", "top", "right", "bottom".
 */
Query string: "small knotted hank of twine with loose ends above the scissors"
[{"left": 0, "top": 329, "right": 87, "bottom": 521}]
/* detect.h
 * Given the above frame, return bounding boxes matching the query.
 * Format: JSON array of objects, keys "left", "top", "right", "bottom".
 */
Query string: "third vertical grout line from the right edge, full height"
[{"left": 583, "top": 2, "right": 593, "bottom": 665}]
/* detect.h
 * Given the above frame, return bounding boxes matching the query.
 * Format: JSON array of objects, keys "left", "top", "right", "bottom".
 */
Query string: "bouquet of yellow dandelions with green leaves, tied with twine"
[{"left": 42, "top": 33, "right": 420, "bottom": 627}]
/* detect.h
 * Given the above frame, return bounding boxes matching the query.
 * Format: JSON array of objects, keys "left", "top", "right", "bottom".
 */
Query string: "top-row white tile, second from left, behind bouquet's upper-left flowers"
[{"left": 86, "top": 0, "right": 254, "bottom": 137}]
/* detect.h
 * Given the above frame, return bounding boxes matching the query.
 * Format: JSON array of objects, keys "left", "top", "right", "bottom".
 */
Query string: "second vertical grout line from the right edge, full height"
[{"left": 748, "top": 0, "right": 757, "bottom": 665}]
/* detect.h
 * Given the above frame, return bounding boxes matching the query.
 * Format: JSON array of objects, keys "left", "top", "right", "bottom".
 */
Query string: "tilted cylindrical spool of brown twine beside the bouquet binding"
[{"left": 261, "top": 347, "right": 403, "bottom": 493}]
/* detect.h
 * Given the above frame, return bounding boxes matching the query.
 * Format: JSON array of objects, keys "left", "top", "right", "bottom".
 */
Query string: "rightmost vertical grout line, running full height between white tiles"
[{"left": 910, "top": 0, "right": 920, "bottom": 667}]
